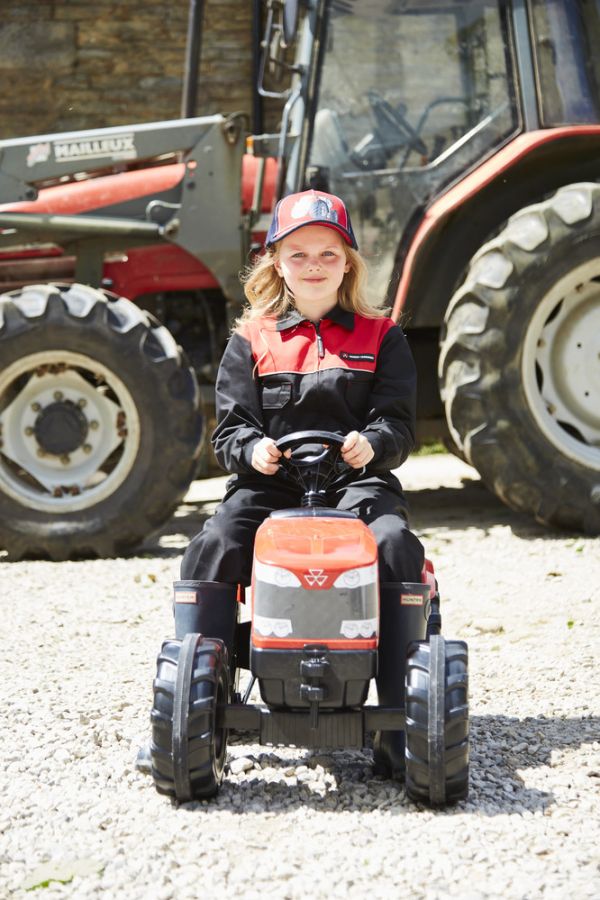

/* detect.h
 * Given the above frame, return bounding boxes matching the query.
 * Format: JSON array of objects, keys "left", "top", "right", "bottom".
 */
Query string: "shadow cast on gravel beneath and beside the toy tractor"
[{"left": 166, "top": 716, "right": 600, "bottom": 817}]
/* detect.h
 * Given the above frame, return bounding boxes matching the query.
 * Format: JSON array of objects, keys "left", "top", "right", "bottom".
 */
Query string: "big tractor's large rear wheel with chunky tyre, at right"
[{"left": 439, "top": 183, "right": 600, "bottom": 534}]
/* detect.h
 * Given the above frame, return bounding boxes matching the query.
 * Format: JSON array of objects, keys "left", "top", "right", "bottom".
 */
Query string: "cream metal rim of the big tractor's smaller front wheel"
[{"left": 0, "top": 350, "right": 140, "bottom": 513}]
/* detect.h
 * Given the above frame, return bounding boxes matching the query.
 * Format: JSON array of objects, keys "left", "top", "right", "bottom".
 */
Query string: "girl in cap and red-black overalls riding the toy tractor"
[{"left": 175, "top": 191, "right": 425, "bottom": 777}]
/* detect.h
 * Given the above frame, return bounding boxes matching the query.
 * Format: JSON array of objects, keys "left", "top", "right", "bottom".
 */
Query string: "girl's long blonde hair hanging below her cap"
[{"left": 234, "top": 241, "right": 387, "bottom": 331}]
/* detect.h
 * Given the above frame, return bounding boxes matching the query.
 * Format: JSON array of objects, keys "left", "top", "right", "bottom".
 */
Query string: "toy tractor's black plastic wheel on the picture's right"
[{"left": 406, "top": 635, "right": 469, "bottom": 806}]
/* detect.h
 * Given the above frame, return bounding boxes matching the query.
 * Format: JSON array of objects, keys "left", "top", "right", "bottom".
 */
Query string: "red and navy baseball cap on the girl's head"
[{"left": 265, "top": 191, "right": 358, "bottom": 250}]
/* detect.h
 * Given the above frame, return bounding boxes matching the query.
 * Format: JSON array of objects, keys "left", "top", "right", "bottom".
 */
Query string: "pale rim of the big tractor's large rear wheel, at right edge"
[{"left": 522, "top": 260, "right": 600, "bottom": 469}]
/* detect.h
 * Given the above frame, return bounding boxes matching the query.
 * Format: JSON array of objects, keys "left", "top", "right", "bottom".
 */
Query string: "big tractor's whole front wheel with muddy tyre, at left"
[{"left": 0, "top": 284, "right": 202, "bottom": 560}]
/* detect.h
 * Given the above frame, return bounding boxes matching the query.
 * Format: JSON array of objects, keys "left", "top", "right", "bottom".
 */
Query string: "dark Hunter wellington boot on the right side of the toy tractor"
[{"left": 373, "top": 582, "right": 427, "bottom": 781}]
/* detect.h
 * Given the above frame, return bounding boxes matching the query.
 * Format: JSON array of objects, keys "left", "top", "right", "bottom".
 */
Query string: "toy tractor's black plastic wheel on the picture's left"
[{"left": 151, "top": 634, "right": 229, "bottom": 803}]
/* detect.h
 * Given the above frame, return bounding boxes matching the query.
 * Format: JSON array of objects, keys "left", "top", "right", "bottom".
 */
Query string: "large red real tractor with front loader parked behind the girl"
[{"left": 0, "top": 0, "right": 600, "bottom": 559}]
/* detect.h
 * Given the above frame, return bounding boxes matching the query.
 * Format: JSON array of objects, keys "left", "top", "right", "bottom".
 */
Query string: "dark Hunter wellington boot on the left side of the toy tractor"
[{"left": 135, "top": 581, "right": 238, "bottom": 775}]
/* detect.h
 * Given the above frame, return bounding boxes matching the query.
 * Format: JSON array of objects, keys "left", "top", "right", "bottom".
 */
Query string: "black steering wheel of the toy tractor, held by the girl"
[{"left": 275, "top": 431, "right": 350, "bottom": 498}]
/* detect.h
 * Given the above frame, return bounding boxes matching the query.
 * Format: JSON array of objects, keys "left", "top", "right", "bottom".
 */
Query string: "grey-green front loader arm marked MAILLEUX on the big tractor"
[{"left": 0, "top": 116, "right": 248, "bottom": 304}]
